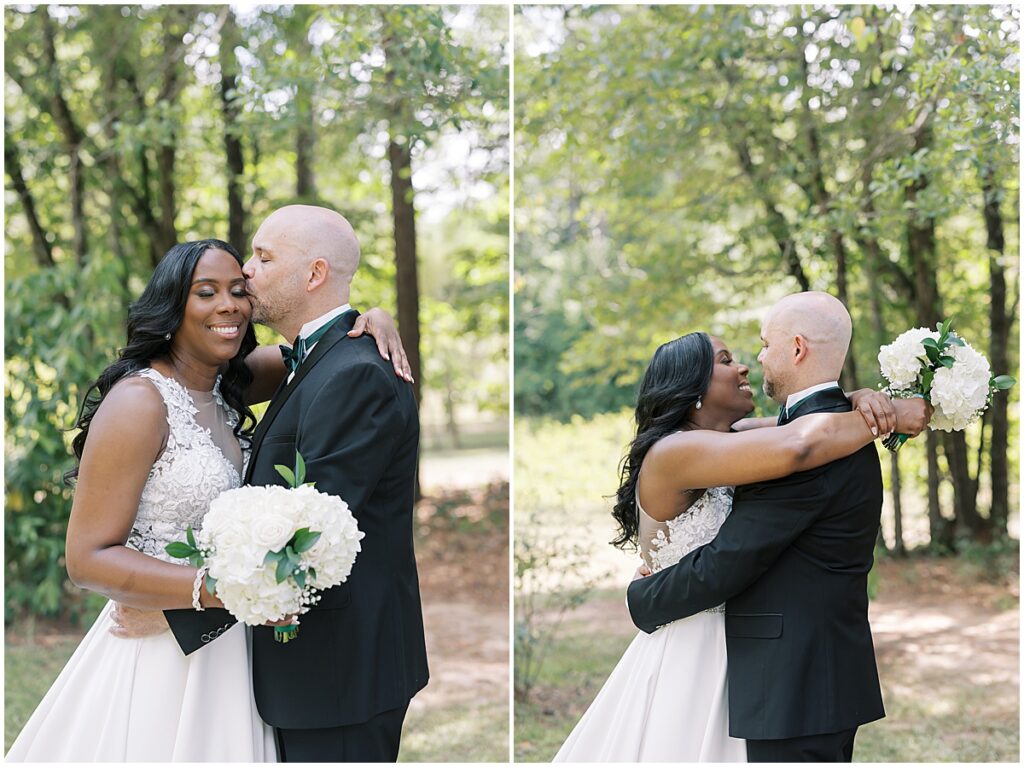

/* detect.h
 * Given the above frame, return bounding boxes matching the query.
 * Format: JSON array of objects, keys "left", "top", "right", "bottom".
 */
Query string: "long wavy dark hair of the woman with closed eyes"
[{"left": 65, "top": 240, "right": 256, "bottom": 484}]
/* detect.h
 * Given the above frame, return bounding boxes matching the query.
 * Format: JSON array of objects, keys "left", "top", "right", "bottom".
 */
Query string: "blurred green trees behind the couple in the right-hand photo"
[{"left": 515, "top": 5, "right": 1020, "bottom": 552}]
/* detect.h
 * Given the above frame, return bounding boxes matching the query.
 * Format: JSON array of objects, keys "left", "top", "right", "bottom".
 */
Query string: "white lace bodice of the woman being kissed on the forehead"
[{"left": 126, "top": 368, "right": 242, "bottom": 563}]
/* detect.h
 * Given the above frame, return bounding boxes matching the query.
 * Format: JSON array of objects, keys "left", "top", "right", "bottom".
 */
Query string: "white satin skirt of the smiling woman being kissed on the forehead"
[{"left": 6, "top": 603, "right": 276, "bottom": 762}]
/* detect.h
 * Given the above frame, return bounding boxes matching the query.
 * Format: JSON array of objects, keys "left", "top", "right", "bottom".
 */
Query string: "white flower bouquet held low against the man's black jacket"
[{"left": 167, "top": 454, "right": 364, "bottom": 642}]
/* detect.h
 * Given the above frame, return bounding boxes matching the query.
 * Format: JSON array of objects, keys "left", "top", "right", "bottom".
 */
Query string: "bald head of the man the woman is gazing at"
[{"left": 759, "top": 291, "right": 853, "bottom": 402}]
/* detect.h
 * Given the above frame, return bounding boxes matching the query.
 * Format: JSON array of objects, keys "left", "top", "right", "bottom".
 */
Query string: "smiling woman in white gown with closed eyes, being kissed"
[{"left": 6, "top": 240, "right": 408, "bottom": 762}]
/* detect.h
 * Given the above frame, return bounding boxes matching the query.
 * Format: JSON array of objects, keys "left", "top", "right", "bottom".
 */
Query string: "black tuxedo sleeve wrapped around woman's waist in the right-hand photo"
[{"left": 626, "top": 469, "right": 828, "bottom": 634}]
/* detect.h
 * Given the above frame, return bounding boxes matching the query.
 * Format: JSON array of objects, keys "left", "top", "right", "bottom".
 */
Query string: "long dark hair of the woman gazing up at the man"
[{"left": 611, "top": 332, "right": 715, "bottom": 549}]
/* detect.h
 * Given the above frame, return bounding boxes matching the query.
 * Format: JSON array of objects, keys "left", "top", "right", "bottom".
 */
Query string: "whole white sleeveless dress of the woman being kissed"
[{"left": 6, "top": 369, "right": 276, "bottom": 762}]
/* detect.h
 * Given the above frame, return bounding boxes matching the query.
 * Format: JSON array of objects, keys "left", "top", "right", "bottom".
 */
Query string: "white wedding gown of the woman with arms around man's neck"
[{"left": 554, "top": 487, "right": 746, "bottom": 762}]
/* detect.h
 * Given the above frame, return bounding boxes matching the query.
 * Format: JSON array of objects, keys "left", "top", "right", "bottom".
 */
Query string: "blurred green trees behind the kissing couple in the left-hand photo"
[{"left": 4, "top": 5, "right": 509, "bottom": 620}]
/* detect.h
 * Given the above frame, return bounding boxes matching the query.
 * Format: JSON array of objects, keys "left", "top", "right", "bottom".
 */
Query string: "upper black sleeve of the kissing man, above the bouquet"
[{"left": 296, "top": 361, "right": 406, "bottom": 507}]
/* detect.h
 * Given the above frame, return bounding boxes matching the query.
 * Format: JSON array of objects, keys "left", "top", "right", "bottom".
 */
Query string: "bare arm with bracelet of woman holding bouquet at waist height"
[{"left": 67, "top": 379, "right": 221, "bottom": 609}]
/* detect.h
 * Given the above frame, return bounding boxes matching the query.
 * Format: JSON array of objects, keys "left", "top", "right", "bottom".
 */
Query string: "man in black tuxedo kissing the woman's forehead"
[{"left": 166, "top": 205, "right": 427, "bottom": 762}]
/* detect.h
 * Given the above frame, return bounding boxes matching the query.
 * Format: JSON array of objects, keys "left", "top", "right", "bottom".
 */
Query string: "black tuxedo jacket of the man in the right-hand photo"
[{"left": 627, "top": 388, "right": 885, "bottom": 740}]
